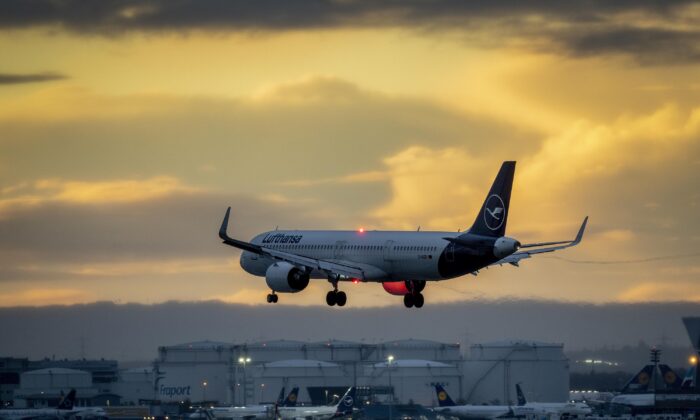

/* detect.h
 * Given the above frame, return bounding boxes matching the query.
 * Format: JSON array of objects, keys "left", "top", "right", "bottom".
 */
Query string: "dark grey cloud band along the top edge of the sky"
[{"left": 0, "top": 0, "right": 700, "bottom": 64}]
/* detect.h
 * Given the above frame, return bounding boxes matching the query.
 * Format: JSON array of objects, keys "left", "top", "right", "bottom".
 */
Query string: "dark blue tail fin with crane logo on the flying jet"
[{"left": 469, "top": 161, "right": 515, "bottom": 237}]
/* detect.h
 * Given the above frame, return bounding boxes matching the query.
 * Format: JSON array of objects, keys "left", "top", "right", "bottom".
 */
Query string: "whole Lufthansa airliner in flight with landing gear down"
[{"left": 219, "top": 161, "right": 588, "bottom": 308}]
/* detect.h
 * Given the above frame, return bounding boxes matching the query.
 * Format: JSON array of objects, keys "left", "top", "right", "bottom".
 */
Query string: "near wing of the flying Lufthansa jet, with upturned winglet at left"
[{"left": 219, "top": 207, "right": 366, "bottom": 280}]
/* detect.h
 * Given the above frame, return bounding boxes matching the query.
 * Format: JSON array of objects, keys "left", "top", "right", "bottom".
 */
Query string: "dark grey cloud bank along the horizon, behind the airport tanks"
[{"left": 0, "top": 301, "right": 700, "bottom": 360}]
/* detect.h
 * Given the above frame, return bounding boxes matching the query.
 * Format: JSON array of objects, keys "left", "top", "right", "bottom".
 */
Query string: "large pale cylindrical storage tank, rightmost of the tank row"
[{"left": 464, "top": 341, "right": 569, "bottom": 404}]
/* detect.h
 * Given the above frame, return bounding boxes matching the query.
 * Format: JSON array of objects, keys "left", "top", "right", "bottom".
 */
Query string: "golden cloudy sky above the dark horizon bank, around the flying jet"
[{"left": 0, "top": 0, "right": 700, "bottom": 307}]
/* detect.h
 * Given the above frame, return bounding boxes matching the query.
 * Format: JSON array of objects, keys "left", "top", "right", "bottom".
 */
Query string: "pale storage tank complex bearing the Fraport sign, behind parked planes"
[{"left": 154, "top": 339, "right": 569, "bottom": 405}]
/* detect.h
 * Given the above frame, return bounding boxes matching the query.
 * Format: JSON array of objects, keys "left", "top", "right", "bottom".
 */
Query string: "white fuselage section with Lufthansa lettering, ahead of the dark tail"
[{"left": 241, "top": 230, "right": 459, "bottom": 281}]
